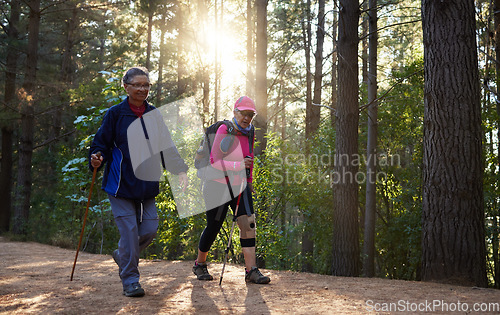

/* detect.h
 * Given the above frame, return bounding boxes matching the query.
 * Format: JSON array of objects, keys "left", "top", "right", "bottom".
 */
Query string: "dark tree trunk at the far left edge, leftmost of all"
[{"left": 0, "top": 0, "right": 21, "bottom": 232}]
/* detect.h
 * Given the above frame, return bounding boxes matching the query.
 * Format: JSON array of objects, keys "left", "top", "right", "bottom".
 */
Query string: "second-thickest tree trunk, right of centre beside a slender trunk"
[{"left": 332, "top": 0, "right": 360, "bottom": 276}]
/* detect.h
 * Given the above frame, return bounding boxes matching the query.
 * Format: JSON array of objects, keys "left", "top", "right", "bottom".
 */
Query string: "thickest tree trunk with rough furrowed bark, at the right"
[{"left": 422, "top": 0, "right": 487, "bottom": 286}]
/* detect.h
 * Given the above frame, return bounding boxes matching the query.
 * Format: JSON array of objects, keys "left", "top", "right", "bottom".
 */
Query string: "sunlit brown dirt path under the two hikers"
[{"left": 0, "top": 237, "right": 500, "bottom": 314}]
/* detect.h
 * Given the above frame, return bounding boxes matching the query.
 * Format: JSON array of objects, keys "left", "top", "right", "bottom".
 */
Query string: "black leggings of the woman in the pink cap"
[{"left": 198, "top": 181, "right": 255, "bottom": 253}]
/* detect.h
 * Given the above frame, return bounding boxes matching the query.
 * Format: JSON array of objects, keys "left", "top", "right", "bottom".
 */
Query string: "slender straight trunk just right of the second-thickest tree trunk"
[{"left": 363, "top": 0, "right": 378, "bottom": 277}]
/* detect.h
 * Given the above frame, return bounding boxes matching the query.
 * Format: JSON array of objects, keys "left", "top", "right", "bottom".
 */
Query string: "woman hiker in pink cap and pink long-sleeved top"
[{"left": 193, "top": 96, "right": 271, "bottom": 284}]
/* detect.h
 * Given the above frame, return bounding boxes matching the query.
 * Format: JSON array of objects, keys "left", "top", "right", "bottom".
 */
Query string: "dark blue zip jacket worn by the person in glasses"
[{"left": 89, "top": 98, "right": 188, "bottom": 200}]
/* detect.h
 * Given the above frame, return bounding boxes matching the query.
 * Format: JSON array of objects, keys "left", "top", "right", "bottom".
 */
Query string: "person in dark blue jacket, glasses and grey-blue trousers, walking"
[{"left": 89, "top": 67, "right": 188, "bottom": 297}]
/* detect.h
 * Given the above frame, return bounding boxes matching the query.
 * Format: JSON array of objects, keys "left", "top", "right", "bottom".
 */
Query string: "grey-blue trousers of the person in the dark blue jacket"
[{"left": 108, "top": 195, "right": 158, "bottom": 288}]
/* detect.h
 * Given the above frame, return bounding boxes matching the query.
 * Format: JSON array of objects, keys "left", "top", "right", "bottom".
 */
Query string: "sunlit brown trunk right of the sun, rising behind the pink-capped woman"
[{"left": 254, "top": 0, "right": 267, "bottom": 155}]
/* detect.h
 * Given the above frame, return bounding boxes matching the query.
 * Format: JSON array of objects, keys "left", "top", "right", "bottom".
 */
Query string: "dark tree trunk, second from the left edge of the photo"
[{"left": 12, "top": 0, "right": 40, "bottom": 234}]
